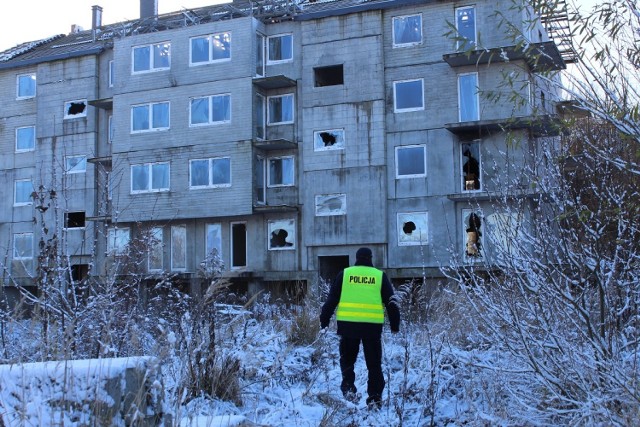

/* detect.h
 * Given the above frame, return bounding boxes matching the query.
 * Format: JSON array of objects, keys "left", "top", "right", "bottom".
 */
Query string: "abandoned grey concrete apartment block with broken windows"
[{"left": 0, "top": 0, "right": 571, "bottom": 300}]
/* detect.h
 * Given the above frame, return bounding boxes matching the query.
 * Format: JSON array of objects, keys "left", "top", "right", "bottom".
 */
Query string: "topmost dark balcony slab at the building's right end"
[{"left": 442, "top": 42, "right": 567, "bottom": 72}]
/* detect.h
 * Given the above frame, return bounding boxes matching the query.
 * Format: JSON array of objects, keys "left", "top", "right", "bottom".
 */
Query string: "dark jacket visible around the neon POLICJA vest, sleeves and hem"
[{"left": 320, "top": 261, "right": 400, "bottom": 338}]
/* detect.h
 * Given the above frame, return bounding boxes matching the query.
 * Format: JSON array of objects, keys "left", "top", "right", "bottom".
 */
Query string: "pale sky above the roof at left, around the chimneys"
[{"left": 0, "top": 0, "right": 231, "bottom": 51}]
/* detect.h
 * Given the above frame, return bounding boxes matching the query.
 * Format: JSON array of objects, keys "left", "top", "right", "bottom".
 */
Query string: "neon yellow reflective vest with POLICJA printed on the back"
[{"left": 336, "top": 265, "right": 384, "bottom": 323}]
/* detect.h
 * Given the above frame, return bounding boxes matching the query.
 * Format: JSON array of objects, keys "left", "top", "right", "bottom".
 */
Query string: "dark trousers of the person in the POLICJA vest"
[{"left": 340, "top": 335, "right": 385, "bottom": 402}]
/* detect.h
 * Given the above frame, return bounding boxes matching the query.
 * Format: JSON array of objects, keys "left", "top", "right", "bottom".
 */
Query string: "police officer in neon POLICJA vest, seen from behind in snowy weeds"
[{"left": 320, "top": 248, "right": 400, "bottom": 408}]
